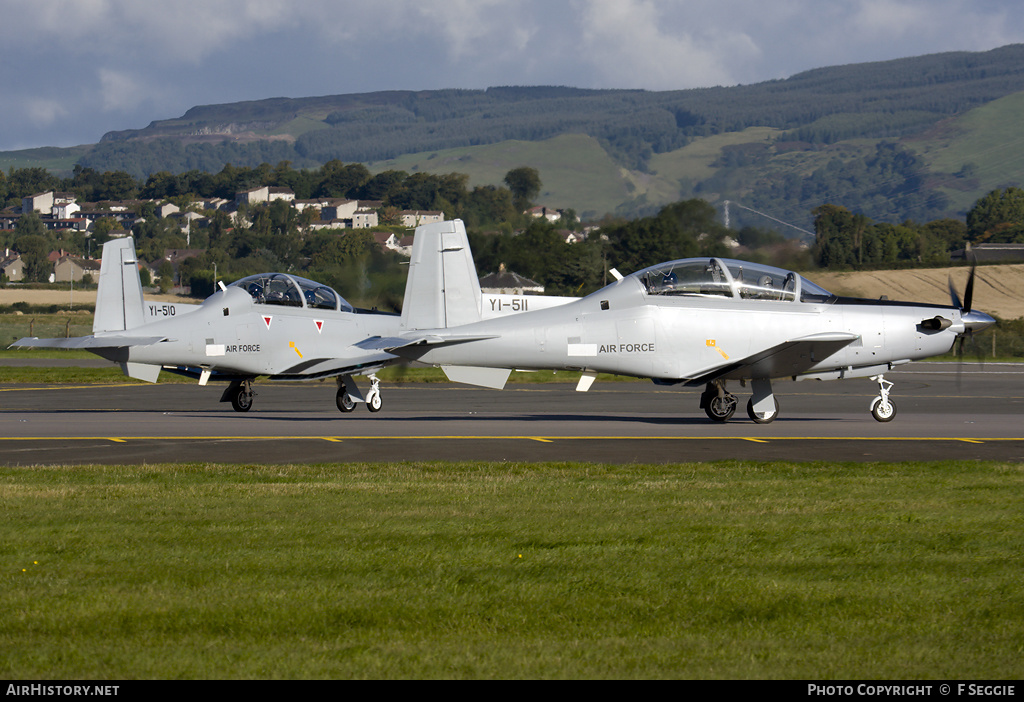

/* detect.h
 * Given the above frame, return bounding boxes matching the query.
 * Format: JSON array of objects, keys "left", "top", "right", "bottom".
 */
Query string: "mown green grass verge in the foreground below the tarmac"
[{"left": 0, "top": 462, "right": 1024, "bottom": 679}]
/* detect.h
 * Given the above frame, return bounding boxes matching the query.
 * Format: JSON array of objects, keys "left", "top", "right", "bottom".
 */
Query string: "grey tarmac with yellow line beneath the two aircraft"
[{"left": 0, "top": 363, "right": 1024, "bottom": 466}]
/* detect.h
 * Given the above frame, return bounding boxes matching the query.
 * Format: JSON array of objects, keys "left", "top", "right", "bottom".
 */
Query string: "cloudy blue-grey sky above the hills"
[{"left": 0, "top": 0, "right": 1024, "bottom": 150}]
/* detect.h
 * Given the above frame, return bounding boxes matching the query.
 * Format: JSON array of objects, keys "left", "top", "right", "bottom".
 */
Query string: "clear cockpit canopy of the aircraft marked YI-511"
[{"left": 634, "top": 258, "right": 836, "bottom": 302}]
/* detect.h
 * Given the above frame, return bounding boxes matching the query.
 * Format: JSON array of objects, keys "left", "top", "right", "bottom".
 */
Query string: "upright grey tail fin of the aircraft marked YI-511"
[{"left": 401, "top": 219, "right": 480, "bottom": 330}]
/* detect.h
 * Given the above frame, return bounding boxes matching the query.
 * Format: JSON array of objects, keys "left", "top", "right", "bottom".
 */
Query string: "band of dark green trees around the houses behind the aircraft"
[{"left": 0, "top": 156, "right": 1024, "bottom": 308}]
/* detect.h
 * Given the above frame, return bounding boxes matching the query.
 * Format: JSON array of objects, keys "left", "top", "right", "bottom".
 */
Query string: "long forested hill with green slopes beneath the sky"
[{"left": 6, "top": 45, "right": 1024, "bottom": 233}]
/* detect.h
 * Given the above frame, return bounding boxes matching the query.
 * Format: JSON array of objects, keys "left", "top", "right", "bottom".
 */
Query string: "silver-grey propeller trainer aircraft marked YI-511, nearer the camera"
[{"left": 383, "top": 218, "right": 994, "bottom": 424}]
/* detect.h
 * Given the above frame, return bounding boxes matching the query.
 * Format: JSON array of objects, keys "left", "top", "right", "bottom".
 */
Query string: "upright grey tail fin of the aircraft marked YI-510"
[{"left": 92, "top": 236, "right": 145, "bottom": 334}]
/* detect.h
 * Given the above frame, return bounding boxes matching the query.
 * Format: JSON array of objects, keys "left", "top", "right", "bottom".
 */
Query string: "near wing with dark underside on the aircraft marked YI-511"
[{"left": 686, "top": 332, "right": 859, "bottom": 386}]
